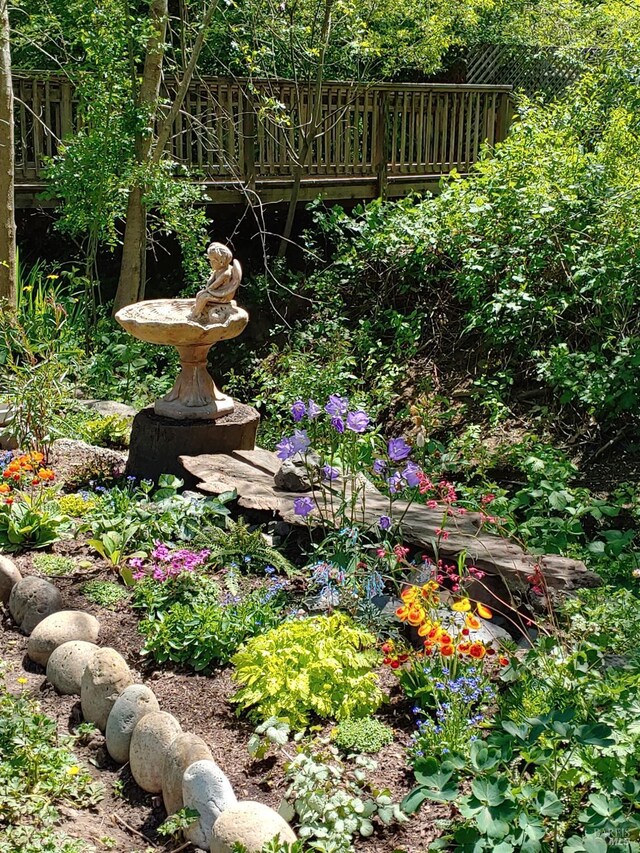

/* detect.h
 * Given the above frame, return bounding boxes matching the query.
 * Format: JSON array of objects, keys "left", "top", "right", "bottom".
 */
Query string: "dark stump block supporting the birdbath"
[{"left": 127, "top": 403, "right": 260, "bottom": 489}]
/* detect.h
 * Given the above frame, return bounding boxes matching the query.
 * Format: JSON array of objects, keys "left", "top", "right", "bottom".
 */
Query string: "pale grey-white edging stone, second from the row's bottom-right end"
[{"left": 182, "top": 760, "right": 238, "bottom": 850}]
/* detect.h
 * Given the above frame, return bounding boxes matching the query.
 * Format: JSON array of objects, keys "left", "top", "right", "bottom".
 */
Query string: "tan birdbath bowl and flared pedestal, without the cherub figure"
[{"left": 116, "top": 299, "right": 249, "bottom": 420}]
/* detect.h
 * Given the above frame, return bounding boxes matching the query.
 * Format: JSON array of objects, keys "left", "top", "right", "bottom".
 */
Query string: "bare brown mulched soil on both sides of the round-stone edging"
[{"left": 0, "top": 541, "right": 448, "bottom": 853}]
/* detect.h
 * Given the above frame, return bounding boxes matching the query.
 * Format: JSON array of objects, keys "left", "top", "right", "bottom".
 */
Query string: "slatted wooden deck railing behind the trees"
[{"left": 14, "top": 73, "right": 511, "bottom": 204}]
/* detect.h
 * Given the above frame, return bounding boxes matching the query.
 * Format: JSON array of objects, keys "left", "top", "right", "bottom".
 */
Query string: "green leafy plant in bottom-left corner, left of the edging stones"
[{"left": 0, "top": 670, "right": 102, "bottom": 853}]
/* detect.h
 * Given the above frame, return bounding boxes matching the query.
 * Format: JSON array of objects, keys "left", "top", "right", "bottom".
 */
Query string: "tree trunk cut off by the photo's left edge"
[{"left": 0, "top": 0, "right": 18, "bottom": 308}]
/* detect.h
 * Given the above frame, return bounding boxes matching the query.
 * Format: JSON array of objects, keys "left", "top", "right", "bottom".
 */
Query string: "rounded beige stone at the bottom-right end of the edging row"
[{"left": 209, "top": 800, "right": 296, "bottom": 853}]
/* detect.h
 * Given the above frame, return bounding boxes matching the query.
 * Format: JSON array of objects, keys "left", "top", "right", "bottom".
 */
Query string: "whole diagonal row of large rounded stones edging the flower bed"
[{"left": 0, "top": 555, "right": 296, "bottom": 853}]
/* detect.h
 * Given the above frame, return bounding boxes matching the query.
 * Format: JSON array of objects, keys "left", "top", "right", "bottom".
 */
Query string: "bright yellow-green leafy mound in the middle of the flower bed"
[{"left": 232, "top": 613, "right": 383, "bottom": 730}]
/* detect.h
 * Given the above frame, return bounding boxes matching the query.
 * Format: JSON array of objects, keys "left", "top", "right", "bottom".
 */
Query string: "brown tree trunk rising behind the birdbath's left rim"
[{"left": 112, "top": 0, "right": 169, "bottom": 313}]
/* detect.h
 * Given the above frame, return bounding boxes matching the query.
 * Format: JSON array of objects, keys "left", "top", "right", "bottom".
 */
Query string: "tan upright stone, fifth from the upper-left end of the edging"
[{"left": 80, "top": 647, "right": 133, "bottom": 731}]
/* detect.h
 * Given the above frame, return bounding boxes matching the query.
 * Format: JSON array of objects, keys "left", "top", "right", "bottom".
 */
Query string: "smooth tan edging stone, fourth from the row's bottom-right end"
[{"left": 129, "top": 711, "right": 182, "bottom": 794}]
